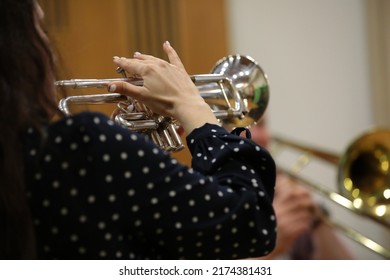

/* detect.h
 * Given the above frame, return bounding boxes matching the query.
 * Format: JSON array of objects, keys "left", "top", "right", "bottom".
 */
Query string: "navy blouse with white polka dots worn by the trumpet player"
[{"left": 24, "top": 112, "right": 276, "bottom": 259}]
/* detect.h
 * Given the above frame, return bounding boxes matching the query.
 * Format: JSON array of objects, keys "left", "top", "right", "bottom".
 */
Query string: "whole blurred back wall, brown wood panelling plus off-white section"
[{"left": 40, "top": 0, "right": 390, "bottom": 259}]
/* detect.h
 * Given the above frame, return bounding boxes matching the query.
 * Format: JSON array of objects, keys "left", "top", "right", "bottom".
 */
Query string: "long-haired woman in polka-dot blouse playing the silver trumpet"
[{"left": 0, "top": 0, "right": 275, "bottom": 259}]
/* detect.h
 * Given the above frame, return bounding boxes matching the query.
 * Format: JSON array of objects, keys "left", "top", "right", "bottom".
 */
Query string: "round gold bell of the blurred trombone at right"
[{"left": 338, "top": 129, "right": 390, "bottom": 218}]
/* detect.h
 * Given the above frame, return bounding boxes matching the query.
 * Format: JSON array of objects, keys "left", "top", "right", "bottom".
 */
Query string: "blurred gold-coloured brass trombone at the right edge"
[{"left": 270, "top": 129, "right": 390, "bottom": 259}]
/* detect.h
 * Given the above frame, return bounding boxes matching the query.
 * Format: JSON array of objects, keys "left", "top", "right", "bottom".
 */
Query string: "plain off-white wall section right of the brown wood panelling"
[{"left": 227, "top": 0, "right": 390, "bottom": 259}]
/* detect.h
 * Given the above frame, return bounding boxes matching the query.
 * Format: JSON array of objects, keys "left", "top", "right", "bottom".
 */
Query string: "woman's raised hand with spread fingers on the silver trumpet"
[{"left": 108, "top": 42, "right": 218, "bottom": 134}]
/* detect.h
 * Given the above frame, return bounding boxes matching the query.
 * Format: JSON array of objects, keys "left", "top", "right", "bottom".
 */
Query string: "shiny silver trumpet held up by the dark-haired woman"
[{"left": 55, "top": 55, "right": 269, "bottom": 152}]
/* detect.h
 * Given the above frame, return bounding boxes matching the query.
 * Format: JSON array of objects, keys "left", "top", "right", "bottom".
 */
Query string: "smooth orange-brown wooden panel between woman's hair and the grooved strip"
[{"left": 41, "top": 0, "right": 130, "bottom": 115}]
